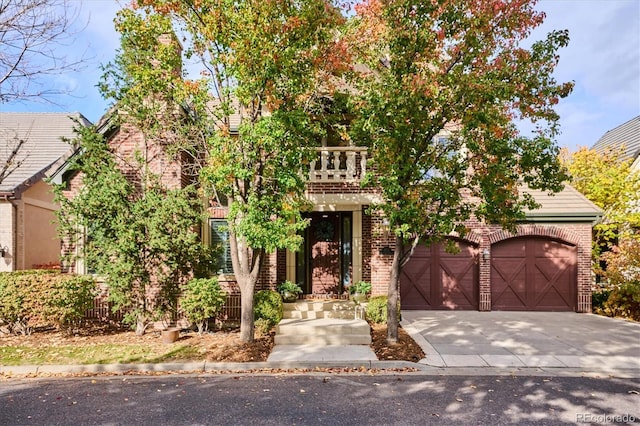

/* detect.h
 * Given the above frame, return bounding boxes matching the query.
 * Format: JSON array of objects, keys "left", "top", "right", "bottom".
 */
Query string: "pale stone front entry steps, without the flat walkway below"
[{"left": 275, "top": 300, "right": 371, "bottom": 345}]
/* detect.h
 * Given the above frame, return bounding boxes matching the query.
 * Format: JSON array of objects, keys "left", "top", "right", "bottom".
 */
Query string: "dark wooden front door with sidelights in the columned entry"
[{"left": 296, "top": 212, "right": 352, "bottom": 295}]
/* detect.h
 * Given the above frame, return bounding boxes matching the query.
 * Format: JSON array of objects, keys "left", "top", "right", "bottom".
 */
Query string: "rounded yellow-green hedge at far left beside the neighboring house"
[{"left": 0, "top": 270, "right": 96, "bottom": 334}]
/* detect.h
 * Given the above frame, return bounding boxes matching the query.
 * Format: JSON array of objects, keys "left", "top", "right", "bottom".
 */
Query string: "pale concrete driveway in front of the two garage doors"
[{"left": 402, "top": 311, "right": 640, "bottom": 370}]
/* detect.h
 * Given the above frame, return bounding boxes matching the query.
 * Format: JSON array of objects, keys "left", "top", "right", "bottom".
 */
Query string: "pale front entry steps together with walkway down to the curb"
[{"left": 267, "top": 300, "right": 378, "bottom": 365}]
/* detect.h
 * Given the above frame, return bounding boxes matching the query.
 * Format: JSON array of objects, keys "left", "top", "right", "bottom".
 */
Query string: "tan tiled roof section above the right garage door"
[{"left": 519, "top": 184, "right": 602, "bottom": 222}]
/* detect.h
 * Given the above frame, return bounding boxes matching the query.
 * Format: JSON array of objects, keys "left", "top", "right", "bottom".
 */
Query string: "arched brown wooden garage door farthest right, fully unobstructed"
[{"left": 491, "top": 237, "right": 578, "bottom": 311}]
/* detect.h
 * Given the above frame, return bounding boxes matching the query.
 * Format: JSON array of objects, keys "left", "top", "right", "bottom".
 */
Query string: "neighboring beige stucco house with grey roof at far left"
[{"left": 0, "top": 112, "right": 89, "bottom": 271}]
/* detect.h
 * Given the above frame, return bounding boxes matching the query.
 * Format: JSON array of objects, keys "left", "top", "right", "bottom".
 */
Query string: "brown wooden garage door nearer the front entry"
[{"left": 400, "top": 242, "right": 478, "bottom": 310}]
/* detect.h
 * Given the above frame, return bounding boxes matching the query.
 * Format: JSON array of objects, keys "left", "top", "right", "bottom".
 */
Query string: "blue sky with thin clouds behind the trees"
[{"left": 0, "top": 0, "right": 640, "bottom": 151}]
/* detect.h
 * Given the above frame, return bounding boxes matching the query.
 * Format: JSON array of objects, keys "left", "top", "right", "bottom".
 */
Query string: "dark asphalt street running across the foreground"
[{"left": 0, "top": 373, "right": 640, "bottom": 426}]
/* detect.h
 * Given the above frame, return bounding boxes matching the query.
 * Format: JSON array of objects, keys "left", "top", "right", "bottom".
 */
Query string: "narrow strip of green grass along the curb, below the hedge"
[{"left": 0, "top": 343, "right": 204, "bottom": 365}]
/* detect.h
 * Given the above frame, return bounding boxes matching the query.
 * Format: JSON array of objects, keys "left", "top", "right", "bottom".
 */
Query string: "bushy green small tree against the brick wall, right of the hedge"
[{"left": 56, "top": 128, "right": 213, "bottom": 334}]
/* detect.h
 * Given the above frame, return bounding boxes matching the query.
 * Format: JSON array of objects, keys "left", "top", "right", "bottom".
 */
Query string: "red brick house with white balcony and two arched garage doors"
[{"left": 58, "top": 103, "right": 601, "bottom": 317}]
